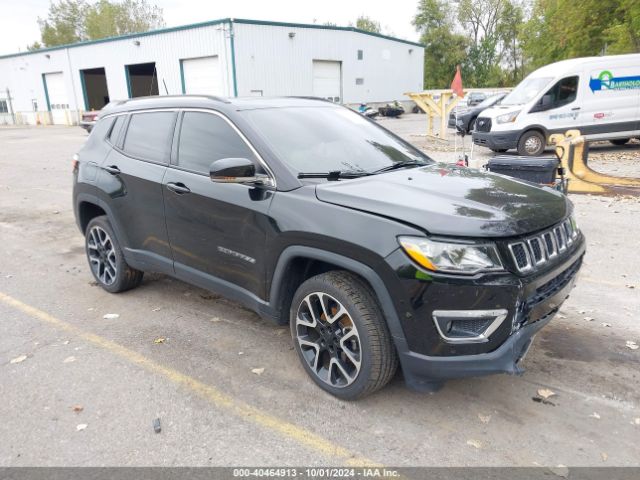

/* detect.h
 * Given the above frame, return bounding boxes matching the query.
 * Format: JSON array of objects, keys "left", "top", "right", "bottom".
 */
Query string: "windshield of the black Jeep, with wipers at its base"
[{"left": 243, "top": 106, "right": 433, "bottom": 173}]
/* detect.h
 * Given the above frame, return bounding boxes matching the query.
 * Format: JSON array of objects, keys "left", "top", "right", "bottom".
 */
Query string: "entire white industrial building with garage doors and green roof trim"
[{"left": 0, "top": 19, "right": 424, "bottom": 124}]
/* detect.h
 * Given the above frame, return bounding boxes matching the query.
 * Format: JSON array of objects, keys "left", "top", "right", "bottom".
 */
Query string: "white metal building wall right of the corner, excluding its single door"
[{"left": 234, "top": 24, "right": 424, "bottom": 103}]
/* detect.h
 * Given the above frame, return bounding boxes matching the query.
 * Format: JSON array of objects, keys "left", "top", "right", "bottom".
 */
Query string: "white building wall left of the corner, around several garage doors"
[{"left": 0, "top": 23, "right": 233, "bottom": 123}]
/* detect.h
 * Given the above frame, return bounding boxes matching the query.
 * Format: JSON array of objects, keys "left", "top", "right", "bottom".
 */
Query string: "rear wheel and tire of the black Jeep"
[{"left": 85, "top": 215, "right": 144, "bottom": 293}]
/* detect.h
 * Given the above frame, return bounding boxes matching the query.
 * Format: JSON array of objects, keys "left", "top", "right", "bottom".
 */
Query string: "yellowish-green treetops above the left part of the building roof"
[{"left": 34, "top": 0, "right": 164, "bottom": 48}]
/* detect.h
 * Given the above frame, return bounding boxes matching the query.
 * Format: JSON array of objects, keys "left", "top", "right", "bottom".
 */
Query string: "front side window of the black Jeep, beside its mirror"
[{"left": 178, "top": 112, "right": 257, "bottom": 174}]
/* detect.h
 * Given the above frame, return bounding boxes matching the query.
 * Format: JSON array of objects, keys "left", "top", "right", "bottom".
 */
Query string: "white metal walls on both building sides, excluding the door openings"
[{"left": 0, "top": 21, "right": 424, "bottom": 123}]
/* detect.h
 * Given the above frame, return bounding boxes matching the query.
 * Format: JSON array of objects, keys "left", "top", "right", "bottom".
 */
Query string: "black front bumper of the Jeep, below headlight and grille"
[{"left": 388, "top": 236, "right": 585, "bottom": 391}]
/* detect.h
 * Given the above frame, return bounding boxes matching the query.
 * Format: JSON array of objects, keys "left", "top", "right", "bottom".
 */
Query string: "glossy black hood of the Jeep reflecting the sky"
[{"left": 316, "top": 165, "right": 570, "bottom": 237}]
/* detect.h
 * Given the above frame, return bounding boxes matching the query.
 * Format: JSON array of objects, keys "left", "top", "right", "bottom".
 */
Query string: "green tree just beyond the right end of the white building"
[{"left": 413, "top": 0, "right": 469, "bottom": 89}]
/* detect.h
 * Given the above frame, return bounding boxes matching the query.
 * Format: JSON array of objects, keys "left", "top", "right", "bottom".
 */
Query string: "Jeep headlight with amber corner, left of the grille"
[{"left": 398, "top": 237, "right": 503, "bottom": 274}]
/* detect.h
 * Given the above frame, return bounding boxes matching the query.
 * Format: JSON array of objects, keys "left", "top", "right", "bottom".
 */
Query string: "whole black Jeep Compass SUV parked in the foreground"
[{"left": 73, "top": 96, "right": 585, "bottom": 399}]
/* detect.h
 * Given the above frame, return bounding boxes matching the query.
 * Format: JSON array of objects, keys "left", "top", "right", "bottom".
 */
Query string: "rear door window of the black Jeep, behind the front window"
[{"left": 123, "top": 112, "right": 175, "bottom": 163}]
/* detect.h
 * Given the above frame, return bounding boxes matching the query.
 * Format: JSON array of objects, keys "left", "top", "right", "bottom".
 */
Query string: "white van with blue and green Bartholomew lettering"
[{"left": 473, "top": 54, "right": 640, "bottom": 155}]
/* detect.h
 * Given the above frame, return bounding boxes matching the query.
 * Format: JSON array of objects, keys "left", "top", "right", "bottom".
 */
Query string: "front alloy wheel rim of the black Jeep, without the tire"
[{"left": 295, "top": 292, "right": 362, "bottom": 388}]
